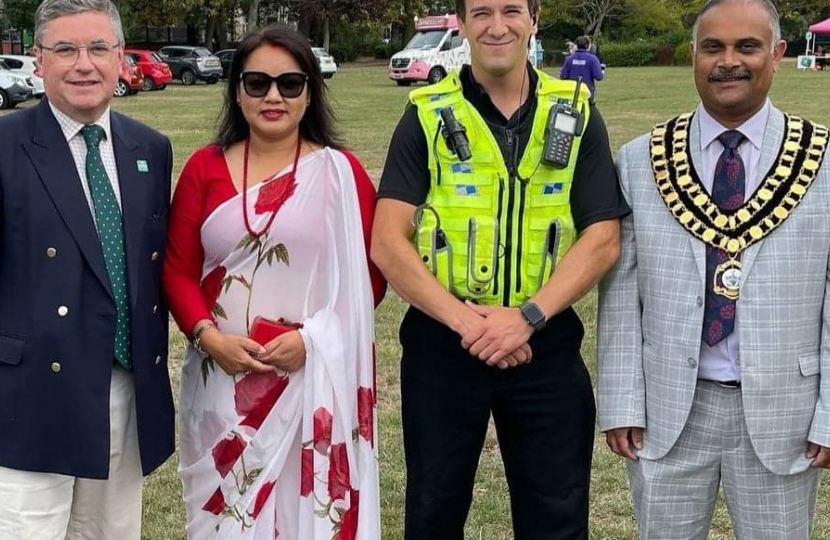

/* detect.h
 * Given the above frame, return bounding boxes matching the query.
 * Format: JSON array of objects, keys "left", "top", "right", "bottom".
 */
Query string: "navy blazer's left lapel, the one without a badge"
[{"left": 23, "top": 99, "right": 112, "bottom": 295}]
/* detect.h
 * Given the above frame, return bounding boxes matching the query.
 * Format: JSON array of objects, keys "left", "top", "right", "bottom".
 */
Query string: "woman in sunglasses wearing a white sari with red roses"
[{"left": 164, "top": 26, "right": 385, "bottom": 540}]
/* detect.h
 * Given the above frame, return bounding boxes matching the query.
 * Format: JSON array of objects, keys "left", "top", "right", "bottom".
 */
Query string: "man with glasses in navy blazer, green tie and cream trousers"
[{"left": 0, "top": 0, "right": 174, "bottom": 540}]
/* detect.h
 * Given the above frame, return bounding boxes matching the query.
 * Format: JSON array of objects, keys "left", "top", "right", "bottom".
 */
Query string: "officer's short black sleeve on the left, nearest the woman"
[{"left": 378, "top": 105, "right": 430, "bottom": 206}]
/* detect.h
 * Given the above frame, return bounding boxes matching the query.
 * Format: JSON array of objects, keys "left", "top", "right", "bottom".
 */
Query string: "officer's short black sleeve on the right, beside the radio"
[{"left": 571, "top": 107, "right": 631, "bottom": 232}]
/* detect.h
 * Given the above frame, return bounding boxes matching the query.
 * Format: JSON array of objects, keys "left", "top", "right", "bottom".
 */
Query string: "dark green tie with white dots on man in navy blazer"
[{"left": 81, "top": 125, "right": 131, "bottom": 369}]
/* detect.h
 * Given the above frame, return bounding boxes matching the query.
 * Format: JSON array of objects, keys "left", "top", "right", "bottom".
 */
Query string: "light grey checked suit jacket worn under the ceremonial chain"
[{"left": 597, "top": 107, "right": 830, "bottom": 474}]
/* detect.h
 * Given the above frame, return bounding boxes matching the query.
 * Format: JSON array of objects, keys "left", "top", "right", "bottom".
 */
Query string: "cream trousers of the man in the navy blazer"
[{"left": 0, "top": 367, "right": 144, "bottom": 540}]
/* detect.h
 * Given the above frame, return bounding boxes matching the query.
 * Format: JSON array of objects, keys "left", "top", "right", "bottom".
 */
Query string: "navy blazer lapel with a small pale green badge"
[{"left": 110, "top": 113, "right": 149, "bottom": 306}]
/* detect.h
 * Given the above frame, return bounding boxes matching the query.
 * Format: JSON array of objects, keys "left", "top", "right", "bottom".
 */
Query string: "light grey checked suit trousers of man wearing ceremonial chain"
[{"left": 628, "top": 381, "right": 821, "bottom": 540}]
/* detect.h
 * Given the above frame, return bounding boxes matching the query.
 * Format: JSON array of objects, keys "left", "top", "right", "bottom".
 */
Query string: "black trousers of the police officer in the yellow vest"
[{"left": 400, "top": 308, "right": 596, "bottom": 540}]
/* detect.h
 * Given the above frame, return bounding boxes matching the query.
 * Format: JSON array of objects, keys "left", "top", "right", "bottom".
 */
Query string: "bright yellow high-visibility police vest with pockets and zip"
[{"left": 409, "top": 71, "right": 590, "bottom": 306}]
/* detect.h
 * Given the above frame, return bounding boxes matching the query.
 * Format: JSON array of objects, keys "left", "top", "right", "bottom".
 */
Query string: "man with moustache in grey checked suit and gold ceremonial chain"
[{"left": 597, "top": 0, "right": 830, "bottom": 540}]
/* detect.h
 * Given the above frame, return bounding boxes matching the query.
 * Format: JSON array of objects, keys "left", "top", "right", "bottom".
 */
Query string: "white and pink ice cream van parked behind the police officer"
[{"left": 389, "top": 14, "right": 536, "bottom": 86}]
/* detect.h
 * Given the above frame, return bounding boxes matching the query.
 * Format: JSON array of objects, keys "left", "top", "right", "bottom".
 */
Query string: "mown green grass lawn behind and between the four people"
[{"left": 3, "top": 63, "right": 830, "bottom": 540}]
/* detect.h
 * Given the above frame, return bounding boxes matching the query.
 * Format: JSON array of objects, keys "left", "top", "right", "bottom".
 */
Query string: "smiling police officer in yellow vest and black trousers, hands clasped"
[{"left": 372, "top": 0, "right": 628, "bottom": 540}]
